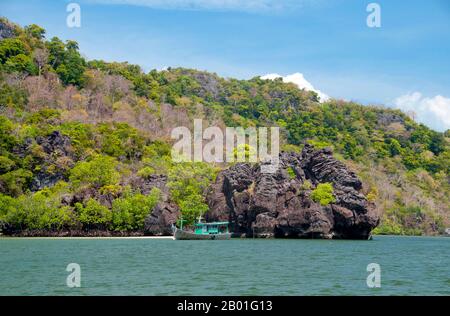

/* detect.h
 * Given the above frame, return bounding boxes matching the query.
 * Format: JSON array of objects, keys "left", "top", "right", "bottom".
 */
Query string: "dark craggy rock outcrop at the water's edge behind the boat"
[{"left": 206, "top": 145, "right": 379, "bottom": 239}]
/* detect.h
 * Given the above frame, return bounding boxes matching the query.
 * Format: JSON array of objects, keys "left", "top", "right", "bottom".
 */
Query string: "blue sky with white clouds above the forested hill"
[{"left": 0, "top": 0, "right": 450, "bottom": 131}]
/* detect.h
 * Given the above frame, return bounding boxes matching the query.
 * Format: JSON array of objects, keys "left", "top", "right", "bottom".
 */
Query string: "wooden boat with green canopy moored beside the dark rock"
[{"left": 172, "top": 218, "right": 231, "bottom": 240}]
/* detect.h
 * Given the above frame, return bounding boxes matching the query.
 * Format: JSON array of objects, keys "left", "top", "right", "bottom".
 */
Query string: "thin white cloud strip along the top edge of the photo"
[{"left": 87, "top": 0, "right": 306, "bottom": 12}]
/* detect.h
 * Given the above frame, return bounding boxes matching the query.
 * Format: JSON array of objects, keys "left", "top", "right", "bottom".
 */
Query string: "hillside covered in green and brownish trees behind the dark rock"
[{"left": 0, "top": 19, "right": 450, "bottom": 235}]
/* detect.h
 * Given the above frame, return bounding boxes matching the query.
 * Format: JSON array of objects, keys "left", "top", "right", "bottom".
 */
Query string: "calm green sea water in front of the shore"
[{"left": 0, "top": 236, "right": 450, "bottom": 295}]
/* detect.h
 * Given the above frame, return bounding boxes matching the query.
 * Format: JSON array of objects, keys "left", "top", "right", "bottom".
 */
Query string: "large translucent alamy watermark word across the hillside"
[{"left": 171, "top": 119, "right": 280, "bottom": 173}]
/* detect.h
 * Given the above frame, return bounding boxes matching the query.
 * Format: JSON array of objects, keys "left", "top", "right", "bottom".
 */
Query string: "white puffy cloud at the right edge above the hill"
[{"left": 394, "top": 92, "right": 450, "bottom": 131}]
